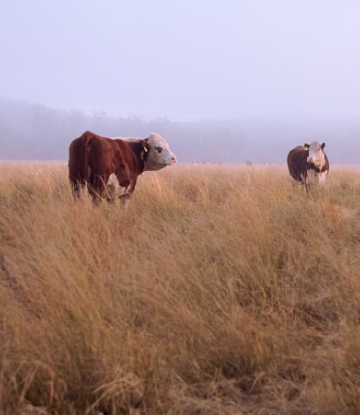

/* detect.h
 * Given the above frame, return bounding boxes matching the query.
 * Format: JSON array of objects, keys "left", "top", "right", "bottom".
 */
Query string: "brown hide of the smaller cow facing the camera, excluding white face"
[{"left": 287, "top": 146, "right": 329, "bottom": 183}]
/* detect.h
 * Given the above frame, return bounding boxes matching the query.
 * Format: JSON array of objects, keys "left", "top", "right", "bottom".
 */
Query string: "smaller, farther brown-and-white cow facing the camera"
[{"left": 287, "top": 141, "right": 329, "bottom": 186}]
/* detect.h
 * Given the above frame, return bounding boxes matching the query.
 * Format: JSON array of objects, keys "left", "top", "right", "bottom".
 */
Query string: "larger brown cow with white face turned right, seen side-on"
[{"left": 69, "top": 131, "right": 176, "bottom": 205}]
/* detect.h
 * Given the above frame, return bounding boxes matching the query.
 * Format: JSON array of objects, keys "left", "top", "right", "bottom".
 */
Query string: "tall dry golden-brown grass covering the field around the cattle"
[{"left": 0, "top": 162, "right": 360, "bottom": 415}]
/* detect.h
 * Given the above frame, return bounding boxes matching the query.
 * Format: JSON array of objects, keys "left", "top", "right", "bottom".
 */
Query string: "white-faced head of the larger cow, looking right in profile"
[{"left": 143, "top": 133, "right": 176, "bottom": 171}]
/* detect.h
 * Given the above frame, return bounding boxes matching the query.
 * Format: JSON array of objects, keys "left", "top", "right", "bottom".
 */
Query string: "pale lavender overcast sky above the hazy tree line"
[{"left": 0, "top": 0, "right": 360, "bottom": 120}]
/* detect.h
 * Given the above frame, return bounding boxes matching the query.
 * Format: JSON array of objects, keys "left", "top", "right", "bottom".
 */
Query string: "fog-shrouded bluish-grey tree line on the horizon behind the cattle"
[{"left": 0, "top": 99, "right": 360, "bottom": 164}]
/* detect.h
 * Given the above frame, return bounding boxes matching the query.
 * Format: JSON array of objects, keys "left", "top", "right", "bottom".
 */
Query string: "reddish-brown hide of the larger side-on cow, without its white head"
[{"left": 69, "top": 131, "right": 147, "bottom": 198}]
